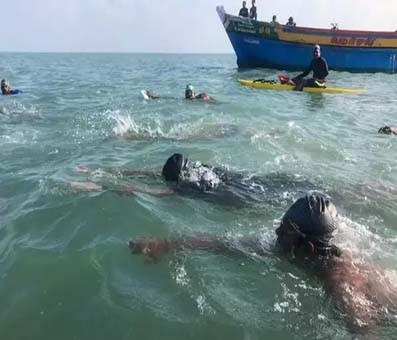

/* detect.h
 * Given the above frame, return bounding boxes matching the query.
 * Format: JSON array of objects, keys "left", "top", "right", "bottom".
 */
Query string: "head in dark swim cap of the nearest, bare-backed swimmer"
[{"left": 276, "top": 194, "right": 341, "bottom": 256}]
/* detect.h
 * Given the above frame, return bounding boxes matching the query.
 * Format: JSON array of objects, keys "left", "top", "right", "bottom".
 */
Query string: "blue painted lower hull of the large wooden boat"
[{"left": 227, "top": 32, "right": 397, "bottom": 73}]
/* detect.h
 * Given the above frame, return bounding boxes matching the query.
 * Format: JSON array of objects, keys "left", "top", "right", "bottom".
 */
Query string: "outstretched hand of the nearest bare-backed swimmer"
[{"left": 128, "top": 238, "right": 171, "bottom": 262}]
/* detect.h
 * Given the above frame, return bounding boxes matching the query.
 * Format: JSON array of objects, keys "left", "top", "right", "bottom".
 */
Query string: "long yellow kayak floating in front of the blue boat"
[{"left": 238, "top": 79, "right": 365, "bottom": 94}]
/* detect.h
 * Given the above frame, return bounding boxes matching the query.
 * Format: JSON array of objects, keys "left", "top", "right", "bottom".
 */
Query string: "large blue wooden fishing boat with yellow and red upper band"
[{"left": 216, "top": 6, "right": 397, "bottom": 73}]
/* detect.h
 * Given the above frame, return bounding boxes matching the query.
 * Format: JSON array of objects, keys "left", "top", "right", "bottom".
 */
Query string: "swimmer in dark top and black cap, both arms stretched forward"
[{"left": 70, "top": 153, "right": 315, "bottom": 206}]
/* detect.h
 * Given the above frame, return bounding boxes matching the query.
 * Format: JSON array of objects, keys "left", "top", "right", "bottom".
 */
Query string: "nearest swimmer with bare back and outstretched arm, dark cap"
[{"left": 129, "top": 194, "right": 397, "bottom": 333}]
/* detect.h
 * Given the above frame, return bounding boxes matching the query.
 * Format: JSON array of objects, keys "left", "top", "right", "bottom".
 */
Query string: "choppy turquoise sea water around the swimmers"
[{"left": 0, "top": 53, "right": 397, "bottom": 340}]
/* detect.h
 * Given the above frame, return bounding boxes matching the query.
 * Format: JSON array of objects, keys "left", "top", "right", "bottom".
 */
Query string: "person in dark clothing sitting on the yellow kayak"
[{"left": 292, "top": 45, "right": 328, "bottom": 91}]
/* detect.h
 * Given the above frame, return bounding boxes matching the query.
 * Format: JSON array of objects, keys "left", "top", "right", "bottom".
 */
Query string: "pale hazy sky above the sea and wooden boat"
[{"left": 0, "top": 0, "right": 397, "bottom": 53}]
